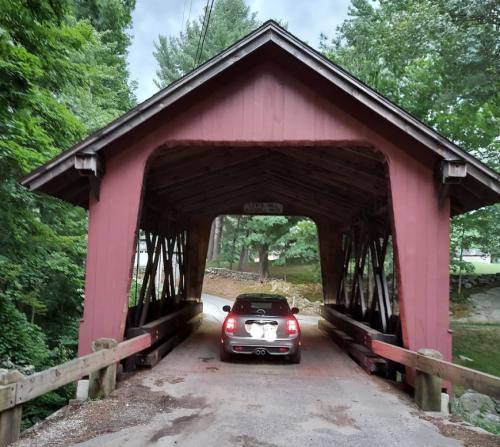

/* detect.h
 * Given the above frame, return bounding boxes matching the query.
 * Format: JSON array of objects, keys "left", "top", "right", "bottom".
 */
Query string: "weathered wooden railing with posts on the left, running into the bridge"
[{"left": 0, "top": 303, "right": 203, "bottom": 447}]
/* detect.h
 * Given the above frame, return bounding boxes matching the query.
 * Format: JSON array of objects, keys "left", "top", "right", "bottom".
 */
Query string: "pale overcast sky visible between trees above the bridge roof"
[{"left": 128, "top": 0, "right": 351, "bottom": 102}]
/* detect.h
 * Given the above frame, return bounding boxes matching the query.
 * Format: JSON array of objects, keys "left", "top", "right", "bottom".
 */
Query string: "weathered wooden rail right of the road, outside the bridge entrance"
[{"left": 372, "top": 340, "right": 500, "bottom": 399}]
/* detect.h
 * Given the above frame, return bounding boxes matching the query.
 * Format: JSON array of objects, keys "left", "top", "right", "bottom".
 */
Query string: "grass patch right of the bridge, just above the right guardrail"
[{"left": 450, "top": 322, "right": 500, "bottom": 396}]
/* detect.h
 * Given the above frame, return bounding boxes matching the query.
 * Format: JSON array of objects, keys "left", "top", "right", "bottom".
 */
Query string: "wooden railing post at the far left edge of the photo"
[{"left": 0, "top": 369, "right": 24, "bottom": 447}]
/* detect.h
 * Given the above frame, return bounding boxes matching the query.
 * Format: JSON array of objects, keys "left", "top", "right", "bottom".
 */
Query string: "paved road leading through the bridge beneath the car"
[{"left": 14, "top": 295, "right": 468, "bottom": 447}]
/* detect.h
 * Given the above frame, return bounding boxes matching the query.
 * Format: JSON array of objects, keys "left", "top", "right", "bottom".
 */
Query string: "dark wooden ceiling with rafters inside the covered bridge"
[{"left": 143, "top": 146, "right": 387, "bottom": 225}]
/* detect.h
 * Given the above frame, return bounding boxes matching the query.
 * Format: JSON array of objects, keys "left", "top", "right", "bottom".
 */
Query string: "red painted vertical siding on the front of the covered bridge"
[{"left": 80, "top": 60, "right": 451, "bottom": 368}]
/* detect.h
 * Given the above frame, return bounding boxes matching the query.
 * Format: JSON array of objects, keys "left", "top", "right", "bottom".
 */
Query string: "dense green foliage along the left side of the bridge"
[{"left": 0, "top": 0, "right": 135, "bottom": 426}]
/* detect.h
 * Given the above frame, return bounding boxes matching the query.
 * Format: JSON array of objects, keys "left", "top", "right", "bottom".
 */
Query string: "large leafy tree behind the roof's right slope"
[{"left": 321, "top": 0, "right": 500, "bottom": 276}]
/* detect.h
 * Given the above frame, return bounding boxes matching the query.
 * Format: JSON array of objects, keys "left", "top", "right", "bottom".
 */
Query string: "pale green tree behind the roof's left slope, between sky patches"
[{"left": 153, "top": 0, "right": 260, "bottom": 88}]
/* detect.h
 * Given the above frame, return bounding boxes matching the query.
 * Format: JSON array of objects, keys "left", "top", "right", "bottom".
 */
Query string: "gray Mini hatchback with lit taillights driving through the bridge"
[{"left": 220, "top": 293, "right": 301, "bottom": 363}]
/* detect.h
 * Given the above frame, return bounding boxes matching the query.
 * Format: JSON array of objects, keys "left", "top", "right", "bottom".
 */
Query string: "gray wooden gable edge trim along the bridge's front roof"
[{"left": 21, "top": 21, "right": 500, "bottom": 200}]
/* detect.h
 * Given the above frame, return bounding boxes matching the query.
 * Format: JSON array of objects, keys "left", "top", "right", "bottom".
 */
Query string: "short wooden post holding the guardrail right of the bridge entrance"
[{"left": 415, "top": 349, "right": 443, "bottom": 411}]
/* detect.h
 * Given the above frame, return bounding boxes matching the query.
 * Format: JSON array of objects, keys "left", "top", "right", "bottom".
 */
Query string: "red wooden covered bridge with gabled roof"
[{"left": 22, "top": 21, "right": 500, "bottom": 378}]
